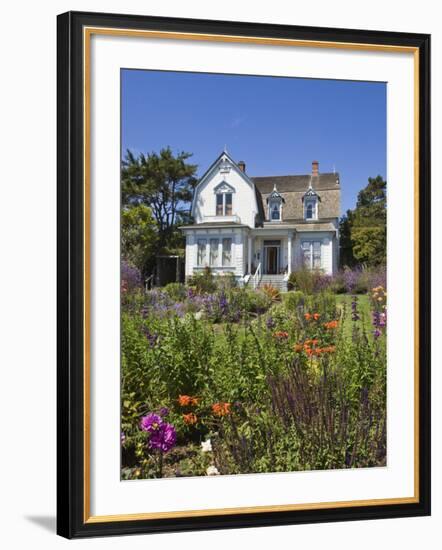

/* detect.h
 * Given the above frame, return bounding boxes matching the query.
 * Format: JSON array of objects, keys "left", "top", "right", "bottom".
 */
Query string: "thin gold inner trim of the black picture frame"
[{"left": 83, "top": 27, "right": 420, "bottom": 524}]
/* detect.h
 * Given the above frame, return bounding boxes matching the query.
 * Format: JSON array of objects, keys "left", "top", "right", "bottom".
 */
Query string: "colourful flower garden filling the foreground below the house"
[{"left": 120, "top": 270, "right": 387, "bottom": 479}]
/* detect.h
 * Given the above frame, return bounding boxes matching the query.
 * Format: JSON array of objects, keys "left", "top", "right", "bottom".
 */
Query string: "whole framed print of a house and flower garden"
[{"left": 58, "top": 12, "right": 430, "bottom": 538}]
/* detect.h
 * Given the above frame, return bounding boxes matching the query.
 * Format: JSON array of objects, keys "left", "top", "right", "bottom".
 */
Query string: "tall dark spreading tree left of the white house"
[{"left": 122, "top": 147, "right": 197, "bottom": 250}]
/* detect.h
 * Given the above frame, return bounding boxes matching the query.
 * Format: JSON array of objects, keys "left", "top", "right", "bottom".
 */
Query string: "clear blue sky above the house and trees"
[{"left": 121, "top": 69, "right": 386, "bottom": 213}]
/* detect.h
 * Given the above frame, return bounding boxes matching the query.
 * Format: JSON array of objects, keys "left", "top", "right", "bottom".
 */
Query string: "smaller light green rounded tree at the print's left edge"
[{"left": 121, "top": 204, "right": 158, "bottom": 273}]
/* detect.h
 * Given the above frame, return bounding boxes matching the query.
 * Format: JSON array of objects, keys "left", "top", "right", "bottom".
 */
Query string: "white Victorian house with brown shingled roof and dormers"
[{"left": 181, "top": 152, "right": 340, "bottom": 287}]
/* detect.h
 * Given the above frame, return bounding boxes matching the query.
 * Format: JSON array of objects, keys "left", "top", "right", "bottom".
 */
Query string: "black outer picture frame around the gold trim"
[{"left": 57, "top": 12, "right": 431, "bottom": 538}]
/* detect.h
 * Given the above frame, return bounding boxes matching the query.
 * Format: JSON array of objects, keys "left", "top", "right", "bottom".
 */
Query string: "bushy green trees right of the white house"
[{"left": 340, "top": 176, "right": 387, "bottom": 266}]
